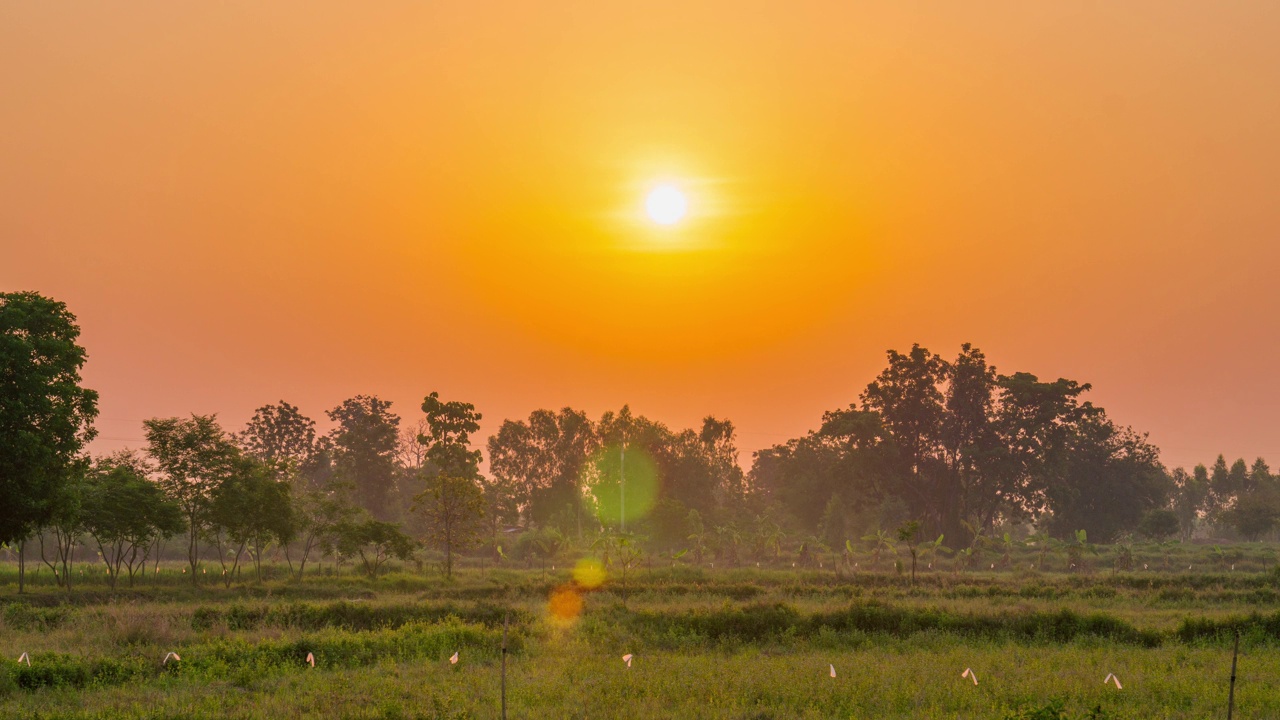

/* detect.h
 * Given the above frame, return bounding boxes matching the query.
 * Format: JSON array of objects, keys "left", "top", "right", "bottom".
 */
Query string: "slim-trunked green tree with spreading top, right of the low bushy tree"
[{"left": 142, "top": 415, "right": 241, "bottom": 584}]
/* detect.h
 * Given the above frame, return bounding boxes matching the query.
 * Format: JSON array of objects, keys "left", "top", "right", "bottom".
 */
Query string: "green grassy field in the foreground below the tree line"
[{"left": 0, "top": 544, "right": 1280, "bottom": 719}]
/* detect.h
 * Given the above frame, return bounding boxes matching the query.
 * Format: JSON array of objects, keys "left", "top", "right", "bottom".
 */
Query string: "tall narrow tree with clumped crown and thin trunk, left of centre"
[{"left": 413, "top": 392, "right": 485, "bottom": 577}]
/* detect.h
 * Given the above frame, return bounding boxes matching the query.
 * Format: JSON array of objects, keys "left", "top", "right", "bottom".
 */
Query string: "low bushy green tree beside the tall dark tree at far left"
[{"left": 82, "top": 451, "right": 183, "bottom": 591}]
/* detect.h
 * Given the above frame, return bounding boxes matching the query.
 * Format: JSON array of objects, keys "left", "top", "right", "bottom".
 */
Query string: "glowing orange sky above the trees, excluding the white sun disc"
[{"left": 0, "top": 0, "right": 1280, "bottom": 465}]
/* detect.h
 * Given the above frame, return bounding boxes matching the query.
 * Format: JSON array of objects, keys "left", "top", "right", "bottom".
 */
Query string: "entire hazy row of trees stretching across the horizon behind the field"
[{"left": 0, "top": 292, "right": 1280, "bottom": 587}]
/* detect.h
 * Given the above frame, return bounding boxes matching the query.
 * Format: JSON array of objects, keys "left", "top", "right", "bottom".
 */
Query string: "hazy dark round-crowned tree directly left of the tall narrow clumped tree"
[{"left": 329, "top": 395, "right": 399, "bottom": 520}]
